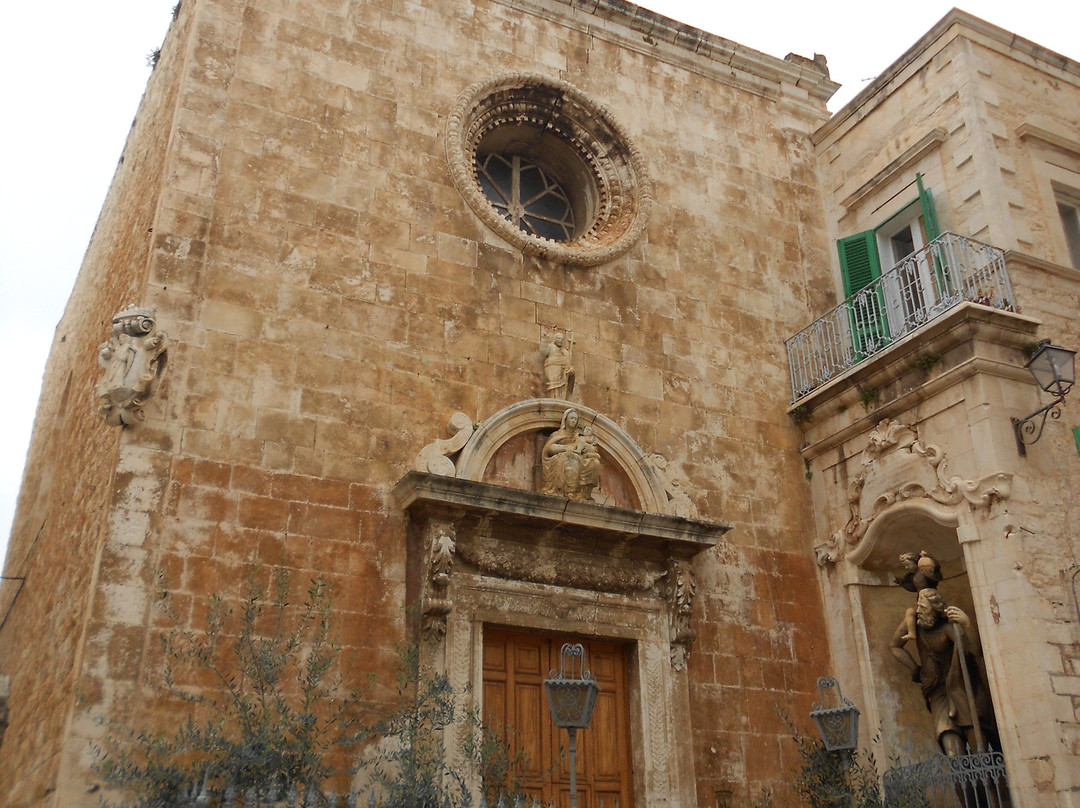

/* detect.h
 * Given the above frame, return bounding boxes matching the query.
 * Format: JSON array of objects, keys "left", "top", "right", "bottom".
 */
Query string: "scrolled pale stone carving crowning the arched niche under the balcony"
[{"left": 814, "top": 418, "right": 1012, "bottom": 566}]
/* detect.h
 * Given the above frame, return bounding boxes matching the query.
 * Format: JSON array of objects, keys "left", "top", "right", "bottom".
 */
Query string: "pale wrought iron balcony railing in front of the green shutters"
[{"left": 785, "top": 233, "right": 1016, "bottom": 403}]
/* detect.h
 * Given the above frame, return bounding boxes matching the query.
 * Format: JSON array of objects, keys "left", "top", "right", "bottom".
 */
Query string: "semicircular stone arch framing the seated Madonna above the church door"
[{"left": 456, "top": 399, "right": 673, "bottom": 514}]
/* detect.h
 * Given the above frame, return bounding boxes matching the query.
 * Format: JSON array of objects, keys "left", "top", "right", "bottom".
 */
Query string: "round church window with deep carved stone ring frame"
[{"left": 447, "top": 76, "right": 649, "bottom": 266}]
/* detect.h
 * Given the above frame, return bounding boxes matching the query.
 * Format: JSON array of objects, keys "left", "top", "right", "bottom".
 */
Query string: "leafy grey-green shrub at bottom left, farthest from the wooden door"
[{"left": 93, "top": 568, "right": 360, "bottom": 808}]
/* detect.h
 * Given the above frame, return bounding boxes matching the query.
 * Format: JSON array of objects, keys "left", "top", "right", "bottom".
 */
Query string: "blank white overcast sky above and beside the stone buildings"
[{"left": 0, "top": 0, "right": 1080, "bottom": 575}]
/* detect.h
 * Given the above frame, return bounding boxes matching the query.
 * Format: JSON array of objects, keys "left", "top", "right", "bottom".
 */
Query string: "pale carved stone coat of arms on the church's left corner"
[{"left": 96, "top": 305, "right": 168, "bottom": 427}]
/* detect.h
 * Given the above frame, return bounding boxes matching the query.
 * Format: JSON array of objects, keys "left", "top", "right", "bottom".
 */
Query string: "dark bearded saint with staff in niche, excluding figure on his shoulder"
[{"left": 890, "top": 588, "right": 997, "bottom": 756}]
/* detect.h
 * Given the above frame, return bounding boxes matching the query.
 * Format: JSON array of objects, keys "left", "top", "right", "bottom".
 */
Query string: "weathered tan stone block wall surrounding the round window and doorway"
[{"left": 3, "top": 0, "right": 842, "bottom": 806}]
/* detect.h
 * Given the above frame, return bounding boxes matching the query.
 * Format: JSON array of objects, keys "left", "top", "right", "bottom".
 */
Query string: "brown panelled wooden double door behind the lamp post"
[{"left": 484, "top": 627, "right": 634, "bottom": 808}]
